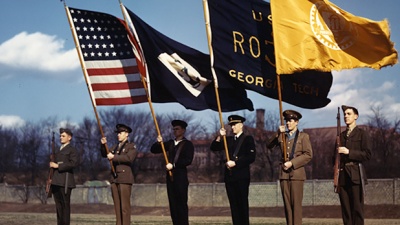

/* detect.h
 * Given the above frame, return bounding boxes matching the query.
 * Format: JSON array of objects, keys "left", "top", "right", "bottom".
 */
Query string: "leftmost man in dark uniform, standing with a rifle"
[{"left": 50, "top": 128, "right": 79, "bottom": 225}]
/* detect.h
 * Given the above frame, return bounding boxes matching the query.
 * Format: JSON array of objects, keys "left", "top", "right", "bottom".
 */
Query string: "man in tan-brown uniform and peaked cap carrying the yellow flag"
[{"left": 267, "top": 110, "right": 313, "bottom": 225}]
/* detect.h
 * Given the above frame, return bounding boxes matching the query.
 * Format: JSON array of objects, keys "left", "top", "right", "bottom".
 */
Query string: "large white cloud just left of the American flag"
[{"left": 0, "top": 32, "right": 79, "bottom": 72}]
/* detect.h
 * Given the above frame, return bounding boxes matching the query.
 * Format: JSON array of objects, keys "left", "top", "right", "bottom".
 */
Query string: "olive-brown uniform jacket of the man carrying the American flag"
[{"left": 100, "top": 142, "right": 137, "bottom": 184}]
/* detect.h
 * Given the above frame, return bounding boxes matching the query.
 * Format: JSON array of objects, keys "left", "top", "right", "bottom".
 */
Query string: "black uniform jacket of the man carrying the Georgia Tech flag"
[{"left": 210, "top": 133, "right": 256, "bottom": 182}]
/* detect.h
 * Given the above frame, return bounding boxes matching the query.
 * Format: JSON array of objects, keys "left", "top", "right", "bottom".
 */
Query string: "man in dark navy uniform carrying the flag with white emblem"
[{"left": 150, "top": 120, "right": 194, "bottom": 225}]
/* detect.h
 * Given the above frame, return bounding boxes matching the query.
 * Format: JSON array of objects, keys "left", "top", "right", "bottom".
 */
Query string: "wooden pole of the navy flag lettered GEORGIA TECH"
[{"left": 203, "top": 0, "right": 230, "bottom": 161}]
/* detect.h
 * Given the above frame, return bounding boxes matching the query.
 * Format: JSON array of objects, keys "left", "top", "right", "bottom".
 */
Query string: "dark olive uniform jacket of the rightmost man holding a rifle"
[{"left": 339, "top": 126, "right": 372, "bottom": 185}]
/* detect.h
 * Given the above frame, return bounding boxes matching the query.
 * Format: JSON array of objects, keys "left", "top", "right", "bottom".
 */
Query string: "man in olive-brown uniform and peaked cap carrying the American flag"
[{"left": 100, "top": 124, "right": 137, "bottom": 225}]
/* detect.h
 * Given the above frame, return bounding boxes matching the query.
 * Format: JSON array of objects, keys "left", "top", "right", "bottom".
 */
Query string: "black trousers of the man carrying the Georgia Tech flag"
[{"left": 225, "top": 179, "right": 250, "bottom": 225}]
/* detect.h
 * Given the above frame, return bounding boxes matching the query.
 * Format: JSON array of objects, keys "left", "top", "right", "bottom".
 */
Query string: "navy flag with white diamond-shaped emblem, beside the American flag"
[{"left": 124, "top": 7, "right": 254, "bottom": 112}]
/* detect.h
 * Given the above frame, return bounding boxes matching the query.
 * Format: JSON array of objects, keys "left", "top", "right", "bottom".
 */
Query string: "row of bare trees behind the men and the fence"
[{"left": 0, "top": 107, "right": 400, "bottom": 186}]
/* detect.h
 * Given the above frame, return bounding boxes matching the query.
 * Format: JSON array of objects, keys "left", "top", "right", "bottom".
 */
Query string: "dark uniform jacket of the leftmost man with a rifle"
[{"left": 51, "top": 144, "right": 79, "bottom": 188}]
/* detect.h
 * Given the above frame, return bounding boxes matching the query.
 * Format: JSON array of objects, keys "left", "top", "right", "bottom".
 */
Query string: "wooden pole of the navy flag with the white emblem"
[{"left": 119, "top": 0, "right": 173, "bottom": 180}]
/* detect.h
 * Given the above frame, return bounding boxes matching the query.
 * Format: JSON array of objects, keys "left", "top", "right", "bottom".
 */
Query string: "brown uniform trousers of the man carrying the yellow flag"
[{"left": 280, "top": 180, "right": 304, "bottom": 225}]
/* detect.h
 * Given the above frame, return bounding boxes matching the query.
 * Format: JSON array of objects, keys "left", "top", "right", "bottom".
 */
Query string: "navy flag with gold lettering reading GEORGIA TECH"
[{"left": 208, "top": 0, "right": 332, "bottom": 109}]
